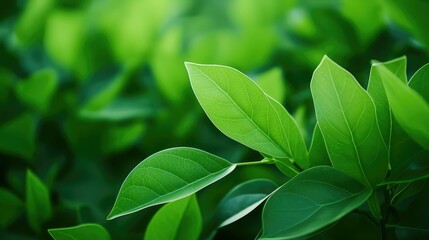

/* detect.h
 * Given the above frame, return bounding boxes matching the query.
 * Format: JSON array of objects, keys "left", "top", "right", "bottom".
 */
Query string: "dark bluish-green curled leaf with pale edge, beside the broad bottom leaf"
[{"left": 214, "top": 179, "right": 277, "bottom": 228}]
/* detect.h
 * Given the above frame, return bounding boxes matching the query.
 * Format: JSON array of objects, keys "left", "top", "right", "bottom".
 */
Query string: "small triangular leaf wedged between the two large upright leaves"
[{"left": 308, "top": 124, "right": 331, "bottom": 167}]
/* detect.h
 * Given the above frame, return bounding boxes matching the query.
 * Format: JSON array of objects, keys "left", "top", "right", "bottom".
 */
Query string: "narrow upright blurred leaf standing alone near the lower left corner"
[{"left": 25, "top": 170, "right": 52, "bottom": 232}]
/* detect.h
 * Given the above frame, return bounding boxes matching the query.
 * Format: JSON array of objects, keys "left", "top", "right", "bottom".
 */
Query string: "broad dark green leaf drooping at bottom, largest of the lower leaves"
[{"left": 261, "top": 166, "right": 372, "bottom": 239}]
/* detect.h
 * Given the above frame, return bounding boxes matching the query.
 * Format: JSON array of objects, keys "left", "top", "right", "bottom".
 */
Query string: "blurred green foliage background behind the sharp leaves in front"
[{"left": 0, "top": 0, "right": 429, "bottom": 239}]
